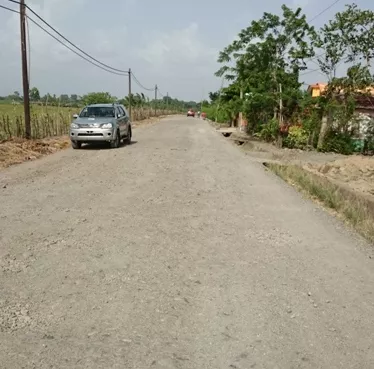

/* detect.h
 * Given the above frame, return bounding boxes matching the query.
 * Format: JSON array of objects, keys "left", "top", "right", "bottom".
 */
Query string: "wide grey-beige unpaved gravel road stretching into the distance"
[{"left": 0, "top": 117, "right": 374, "bottom": 369}]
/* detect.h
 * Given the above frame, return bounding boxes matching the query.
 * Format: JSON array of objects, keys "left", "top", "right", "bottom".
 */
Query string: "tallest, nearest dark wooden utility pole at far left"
[{"left": 19, "top": 0, "right": 31, "bottom": 140}]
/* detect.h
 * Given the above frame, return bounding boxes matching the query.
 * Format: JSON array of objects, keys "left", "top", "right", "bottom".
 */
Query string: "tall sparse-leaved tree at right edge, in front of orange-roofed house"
[{"left": 314, "top": 4, "right": 374, "bottom": 150}]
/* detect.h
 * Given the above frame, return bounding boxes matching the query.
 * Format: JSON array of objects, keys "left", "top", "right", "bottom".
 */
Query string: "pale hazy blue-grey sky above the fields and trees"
[{"left": 0, "top": 0, "right": 374, "bottom": 100}]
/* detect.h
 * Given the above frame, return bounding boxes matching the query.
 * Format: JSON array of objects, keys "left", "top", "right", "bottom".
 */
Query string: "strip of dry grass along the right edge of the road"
[{"left": 268, "top": 163, "right": 374, "bottom": 242}]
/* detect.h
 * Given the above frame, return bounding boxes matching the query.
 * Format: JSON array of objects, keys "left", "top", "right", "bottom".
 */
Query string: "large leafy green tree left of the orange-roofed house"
[{"left": 216, "top": 5, "right": 315, "bottom": 130}]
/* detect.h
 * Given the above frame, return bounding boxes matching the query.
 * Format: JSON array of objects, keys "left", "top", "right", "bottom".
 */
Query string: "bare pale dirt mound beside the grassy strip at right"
[{"left": 306, "top": 156, "right": 374, "bottom": 195}]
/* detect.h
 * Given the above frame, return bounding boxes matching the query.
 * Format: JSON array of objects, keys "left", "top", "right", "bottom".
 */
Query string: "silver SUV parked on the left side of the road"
[{"left": 70, "top": 104, "right": 132, "bottom": 149}]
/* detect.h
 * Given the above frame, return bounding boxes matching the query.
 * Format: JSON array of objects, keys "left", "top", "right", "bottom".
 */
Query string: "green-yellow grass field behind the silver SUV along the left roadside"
[{"left": 0, "top": 104, "right": 173, "bottom": 141}]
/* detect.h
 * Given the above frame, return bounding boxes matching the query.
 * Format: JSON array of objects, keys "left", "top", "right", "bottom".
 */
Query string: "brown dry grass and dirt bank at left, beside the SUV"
[{"left": 0, "top": 137, "right": 70, "bottom": 169}]
